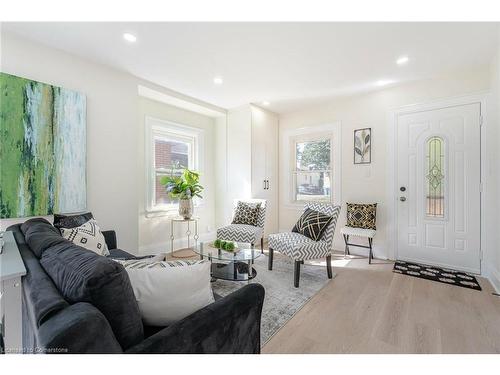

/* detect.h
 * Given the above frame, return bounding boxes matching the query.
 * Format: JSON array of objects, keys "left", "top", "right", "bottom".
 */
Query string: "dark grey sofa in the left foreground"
[{"left": 7, "top": 218, "right": 264, "bottom": 353}]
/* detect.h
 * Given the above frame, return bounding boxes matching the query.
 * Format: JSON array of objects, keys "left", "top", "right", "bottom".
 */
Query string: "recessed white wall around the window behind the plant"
[{"left": 137, "top": 98, "right": 215, "bottom": 254}]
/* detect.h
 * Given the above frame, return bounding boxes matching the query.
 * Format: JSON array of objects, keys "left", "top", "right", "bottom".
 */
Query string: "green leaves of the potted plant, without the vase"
[{"left": 160, "top": 165, "right": 204, "bottom": 199}]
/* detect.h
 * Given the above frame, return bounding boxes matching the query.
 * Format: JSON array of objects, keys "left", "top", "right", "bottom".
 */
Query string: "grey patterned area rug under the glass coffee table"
[{"left": 212, "top": 253, "right": 335, "bottom": 346}]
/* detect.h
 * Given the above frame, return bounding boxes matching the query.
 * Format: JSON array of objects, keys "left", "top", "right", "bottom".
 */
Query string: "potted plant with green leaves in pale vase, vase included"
[{"left": 160, "top": 166, "right": 204, "bottom": 219}]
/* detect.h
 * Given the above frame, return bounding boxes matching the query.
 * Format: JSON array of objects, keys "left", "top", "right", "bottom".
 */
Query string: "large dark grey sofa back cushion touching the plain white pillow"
[{"left": 40, "top": 241, "right": 144, "bottom": 349}]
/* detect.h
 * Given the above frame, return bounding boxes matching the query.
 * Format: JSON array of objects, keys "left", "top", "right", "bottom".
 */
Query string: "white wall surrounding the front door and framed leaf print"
[{"left": 279, "top": 67, "right": 490, "bottom": 258}]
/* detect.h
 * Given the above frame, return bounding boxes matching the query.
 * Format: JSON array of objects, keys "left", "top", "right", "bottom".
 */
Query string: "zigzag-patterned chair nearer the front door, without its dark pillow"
[{"left": 268, "top": 203, "right": 340, "bottom": 288}]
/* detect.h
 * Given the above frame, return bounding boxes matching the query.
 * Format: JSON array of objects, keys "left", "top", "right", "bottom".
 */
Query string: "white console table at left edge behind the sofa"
[{"left": 0, "top": 232, "right": 26, "bottom": 353}]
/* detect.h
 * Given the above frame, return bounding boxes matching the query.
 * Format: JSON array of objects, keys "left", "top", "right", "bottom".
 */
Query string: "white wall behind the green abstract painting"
[{"left": 0, "top": 32, "right": 139, "bottom": 252}]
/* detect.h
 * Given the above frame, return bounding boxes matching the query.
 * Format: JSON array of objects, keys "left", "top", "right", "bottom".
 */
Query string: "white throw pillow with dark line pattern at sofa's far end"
[{"left": 60, "top": 219, "right": 109, "bottom": 256}]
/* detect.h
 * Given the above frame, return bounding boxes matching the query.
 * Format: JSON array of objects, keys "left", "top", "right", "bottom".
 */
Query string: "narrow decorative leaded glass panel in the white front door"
[{"left": 425, "top": 136, "right": 446, "bottom": 218}]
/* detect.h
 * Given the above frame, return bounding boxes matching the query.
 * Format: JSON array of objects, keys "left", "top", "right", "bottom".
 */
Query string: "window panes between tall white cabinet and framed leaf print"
[{"left": 292, "top": 137, "right": 333, "bottom": 202}]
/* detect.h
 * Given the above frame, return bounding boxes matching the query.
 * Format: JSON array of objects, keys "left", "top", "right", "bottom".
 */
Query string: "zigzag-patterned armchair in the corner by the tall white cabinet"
[{"left": 217, "top": 199, "right": 266, "bottom": 253}]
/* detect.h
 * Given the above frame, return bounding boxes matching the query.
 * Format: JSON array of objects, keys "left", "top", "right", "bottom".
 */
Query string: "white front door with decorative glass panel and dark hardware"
[{"left": 397, "top": 103, "right": 481, "bottom": 273}]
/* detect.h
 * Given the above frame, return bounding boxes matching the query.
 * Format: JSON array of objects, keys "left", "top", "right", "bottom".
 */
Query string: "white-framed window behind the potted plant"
[{"left": 146, "top": 118, "right": 200, "bottom": 212}]
